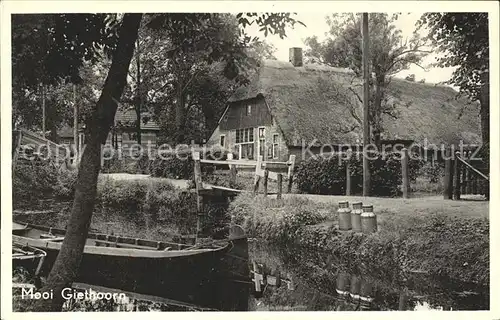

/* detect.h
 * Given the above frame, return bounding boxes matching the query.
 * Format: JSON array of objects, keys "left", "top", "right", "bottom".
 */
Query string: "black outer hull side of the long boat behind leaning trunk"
[{"left": 40, "top": 244, "right": 223, "bottom": 307}]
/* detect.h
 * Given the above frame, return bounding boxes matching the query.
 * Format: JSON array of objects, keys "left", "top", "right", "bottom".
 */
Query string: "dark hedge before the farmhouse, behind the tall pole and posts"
[{"left": 294, "top": 154, "right": 422, "bottom": 196}]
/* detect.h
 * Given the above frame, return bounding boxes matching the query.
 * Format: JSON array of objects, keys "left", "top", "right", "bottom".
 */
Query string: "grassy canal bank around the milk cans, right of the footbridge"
[{"left": 229, "top": 195, "right": 489, "bottom": 287}]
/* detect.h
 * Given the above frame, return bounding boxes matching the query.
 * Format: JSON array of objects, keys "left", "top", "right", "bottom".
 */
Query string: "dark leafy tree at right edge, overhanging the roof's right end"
[{"left": 417, "top": 12, "right": 490, "bottom": 163}]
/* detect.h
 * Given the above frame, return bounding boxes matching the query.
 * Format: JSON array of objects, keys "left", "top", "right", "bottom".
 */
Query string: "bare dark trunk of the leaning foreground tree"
[{"left": 32, "top": 13, "right": 142, "bottom": 311}]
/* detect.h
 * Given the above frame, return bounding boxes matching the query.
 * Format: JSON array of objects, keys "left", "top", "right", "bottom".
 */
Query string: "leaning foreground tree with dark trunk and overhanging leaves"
[{"left": 13, "top": 13, "right": 302, "bottom": 311}]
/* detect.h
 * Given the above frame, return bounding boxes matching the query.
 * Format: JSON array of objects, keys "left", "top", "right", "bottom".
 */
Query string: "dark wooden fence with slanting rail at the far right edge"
[{"left": 443, "top": 150, "right": 490, "bottom": 200}]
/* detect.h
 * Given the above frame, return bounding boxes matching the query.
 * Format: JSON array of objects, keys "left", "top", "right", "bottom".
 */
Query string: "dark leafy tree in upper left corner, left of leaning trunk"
[{"left": 12, "top": 14, "right": 116, "bottom": 140}]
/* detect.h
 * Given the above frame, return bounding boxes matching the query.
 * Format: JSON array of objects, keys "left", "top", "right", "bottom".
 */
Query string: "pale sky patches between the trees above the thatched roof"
[{"left": 248, "top": 12, "right": 454, "bottom": 83}]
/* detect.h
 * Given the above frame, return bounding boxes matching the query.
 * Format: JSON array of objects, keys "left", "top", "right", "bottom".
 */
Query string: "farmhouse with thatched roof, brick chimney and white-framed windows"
[{"left": 208, "top": 48, "right": 481, "bottom": 159}]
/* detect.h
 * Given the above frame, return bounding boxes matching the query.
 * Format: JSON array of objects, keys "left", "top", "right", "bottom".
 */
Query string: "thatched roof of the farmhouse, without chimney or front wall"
[{"left": 229, "top": 60, "right": 481, "bottom": 146}]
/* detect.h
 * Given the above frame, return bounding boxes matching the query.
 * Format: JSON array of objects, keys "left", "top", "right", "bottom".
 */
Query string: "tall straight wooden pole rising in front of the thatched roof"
[{"left": 362, "top": 13, "right": 371, "bottom": 197}]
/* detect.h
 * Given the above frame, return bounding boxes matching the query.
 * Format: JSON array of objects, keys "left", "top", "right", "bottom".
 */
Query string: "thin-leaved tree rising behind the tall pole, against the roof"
[{"left": 305, "top": 13, "right": 429, "bottom": 146}]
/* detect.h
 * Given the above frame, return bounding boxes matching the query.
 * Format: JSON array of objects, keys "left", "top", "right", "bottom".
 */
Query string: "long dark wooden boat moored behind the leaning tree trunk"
[{"left": 12, "top": 222, "right": 246, "bottom": 306}]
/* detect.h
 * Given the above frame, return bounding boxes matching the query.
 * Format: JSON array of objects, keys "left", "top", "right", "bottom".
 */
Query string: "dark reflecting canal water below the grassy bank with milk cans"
[{"left": 249, "top": 242, "right": 489, "bottom": 311}]
